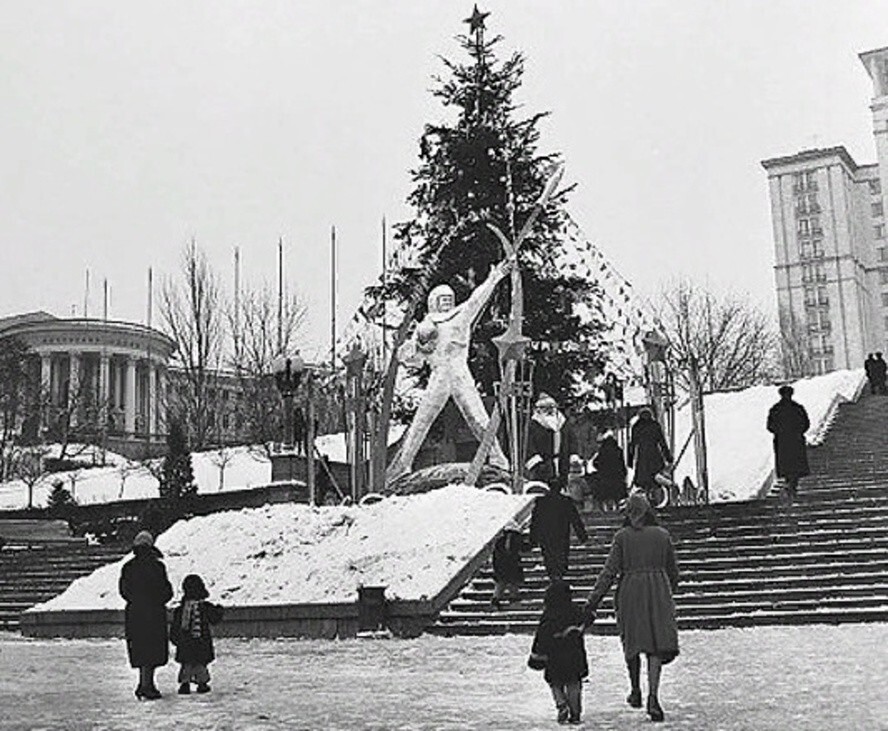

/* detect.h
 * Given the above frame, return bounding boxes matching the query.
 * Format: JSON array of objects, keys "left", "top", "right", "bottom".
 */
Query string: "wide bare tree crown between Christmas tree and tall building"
[{"left": 652, "top": 279, "right": 778, "bottom": 392}]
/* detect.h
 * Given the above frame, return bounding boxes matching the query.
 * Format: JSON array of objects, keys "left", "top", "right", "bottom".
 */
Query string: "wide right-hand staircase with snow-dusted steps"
[{"left": 431, "top": 395, "right": 888, "bottom": 635}]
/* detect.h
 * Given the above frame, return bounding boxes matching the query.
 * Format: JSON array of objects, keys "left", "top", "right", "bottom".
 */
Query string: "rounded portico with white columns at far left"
[{"left": 0, "top": 313, "right": 174, "bottom": 454}]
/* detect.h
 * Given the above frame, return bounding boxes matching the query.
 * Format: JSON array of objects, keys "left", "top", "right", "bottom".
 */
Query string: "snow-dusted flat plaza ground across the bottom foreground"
[{"left": 0, "top": 624, "right": 888, "bottom": 731}]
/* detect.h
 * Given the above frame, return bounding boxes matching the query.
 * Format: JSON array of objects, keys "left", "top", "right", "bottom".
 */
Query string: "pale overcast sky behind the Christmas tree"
[{"left": 0, "top": 0, "right": 888, "bottom": 352}]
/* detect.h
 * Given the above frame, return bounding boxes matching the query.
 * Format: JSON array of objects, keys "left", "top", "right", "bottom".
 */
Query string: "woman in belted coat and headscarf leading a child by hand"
[{"left": 586, "top": 492, "right": 678, "bottom": 721}]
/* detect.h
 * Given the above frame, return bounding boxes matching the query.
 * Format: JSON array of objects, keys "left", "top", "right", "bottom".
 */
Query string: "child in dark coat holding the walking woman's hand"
[{"left": 527, "top": 579, "right": 589, "bottom": 724}]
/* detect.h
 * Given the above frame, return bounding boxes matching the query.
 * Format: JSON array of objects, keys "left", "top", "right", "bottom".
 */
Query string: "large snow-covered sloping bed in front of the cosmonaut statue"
[{"left": 35, "top": 485, "right": 531, "bottom": 610}]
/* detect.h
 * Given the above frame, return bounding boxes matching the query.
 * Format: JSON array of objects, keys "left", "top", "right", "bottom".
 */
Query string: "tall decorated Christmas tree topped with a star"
[{"left": 381, "top": 7, "right": 603, "bottom": 405}]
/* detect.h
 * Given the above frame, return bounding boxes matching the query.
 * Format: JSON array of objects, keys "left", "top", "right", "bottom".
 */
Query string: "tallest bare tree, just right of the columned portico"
[{"left": 160, "top": 240, "right": 225, "bottom": 449}]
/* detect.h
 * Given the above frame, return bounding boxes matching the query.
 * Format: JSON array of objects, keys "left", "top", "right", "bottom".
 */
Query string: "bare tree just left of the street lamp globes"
[{"left": 228, "top": 286, "right": 306, "bottom": 457}]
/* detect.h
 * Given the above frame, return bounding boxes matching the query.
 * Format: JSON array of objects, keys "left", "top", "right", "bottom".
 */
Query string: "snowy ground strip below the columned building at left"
[{"left": 0, "top": 445, "right": 271, "bottom": 510}]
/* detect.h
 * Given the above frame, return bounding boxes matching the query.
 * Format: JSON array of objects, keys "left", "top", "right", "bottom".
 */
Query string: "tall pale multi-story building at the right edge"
[{"left": 762, "top": 48, "right": 888, "bottom": 374}]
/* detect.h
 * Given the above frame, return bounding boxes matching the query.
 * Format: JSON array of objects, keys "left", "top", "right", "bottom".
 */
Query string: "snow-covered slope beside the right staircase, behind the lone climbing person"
[{"left": 675, "top": 369, "right": 866, "bottom": 502}]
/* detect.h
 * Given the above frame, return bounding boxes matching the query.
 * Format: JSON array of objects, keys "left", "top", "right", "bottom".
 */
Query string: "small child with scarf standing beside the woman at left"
[{"left": 170, "top": 574, "right": 222, "bottom": 695}]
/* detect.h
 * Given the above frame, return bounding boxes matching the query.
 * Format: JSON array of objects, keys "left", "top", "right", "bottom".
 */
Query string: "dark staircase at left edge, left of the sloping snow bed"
[{"left": 0, "top": 544, "right": 126, "bottom": 631}]
